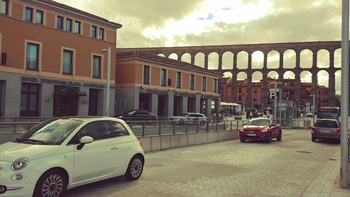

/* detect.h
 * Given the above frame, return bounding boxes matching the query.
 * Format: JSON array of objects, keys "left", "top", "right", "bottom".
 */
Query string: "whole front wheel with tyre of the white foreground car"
[{"left": 33, "top": 169, "right": 67, "bottom": 197}]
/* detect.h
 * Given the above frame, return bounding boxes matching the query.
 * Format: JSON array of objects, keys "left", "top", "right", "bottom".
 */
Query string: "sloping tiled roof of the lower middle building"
[{"left": 116, "top": 50, "right": 221, "bottom": 75}]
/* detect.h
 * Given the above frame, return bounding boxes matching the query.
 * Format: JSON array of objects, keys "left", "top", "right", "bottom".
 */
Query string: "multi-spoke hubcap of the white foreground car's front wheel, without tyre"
[{"left": 41, "top": 174, "right": 63, "bottom": 197}]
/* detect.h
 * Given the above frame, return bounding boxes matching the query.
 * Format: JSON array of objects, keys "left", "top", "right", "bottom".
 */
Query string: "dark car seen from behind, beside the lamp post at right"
[{"left": 311, "top": 119, "right": 340, "bottom": 142}]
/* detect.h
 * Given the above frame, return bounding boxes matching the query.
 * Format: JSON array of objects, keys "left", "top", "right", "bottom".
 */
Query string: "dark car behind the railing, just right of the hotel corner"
[{"left": 115, "top": 110, "right": 158, "bottom": 121}]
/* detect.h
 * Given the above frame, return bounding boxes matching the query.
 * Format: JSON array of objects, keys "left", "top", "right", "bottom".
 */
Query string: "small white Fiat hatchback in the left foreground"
[{"left": 0, "top": 117, "right": 145, "bottom": 197}]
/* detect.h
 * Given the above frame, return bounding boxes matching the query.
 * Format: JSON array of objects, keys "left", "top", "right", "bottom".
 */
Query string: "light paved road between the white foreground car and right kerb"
[{"left": 66, "top": 130, "right": 340, "bottom": 197}]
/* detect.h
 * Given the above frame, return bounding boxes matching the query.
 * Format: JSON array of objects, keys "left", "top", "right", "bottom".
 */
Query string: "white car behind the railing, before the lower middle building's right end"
[{"left": 169, "top": 112, "right": 208, "bottom": 124}]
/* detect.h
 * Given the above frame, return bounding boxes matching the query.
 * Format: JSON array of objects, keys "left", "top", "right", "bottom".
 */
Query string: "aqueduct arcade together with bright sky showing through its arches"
[{"left": 117, "top": 41, "right": 348, "bottom": 111}]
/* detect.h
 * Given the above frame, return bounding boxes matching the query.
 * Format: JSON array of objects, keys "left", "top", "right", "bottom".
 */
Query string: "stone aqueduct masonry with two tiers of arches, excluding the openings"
[{"left": 117, "top": 41, "right": 350, "bottom": 108}]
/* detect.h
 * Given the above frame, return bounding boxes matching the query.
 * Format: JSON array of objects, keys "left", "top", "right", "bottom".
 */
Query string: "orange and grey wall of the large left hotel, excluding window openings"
[{"left": 0, "top": 0, "right": 121, "bottom": 117}]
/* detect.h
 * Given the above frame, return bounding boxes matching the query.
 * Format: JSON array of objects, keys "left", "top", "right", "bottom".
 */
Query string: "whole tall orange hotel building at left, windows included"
[{"left": 0, "top": 0, "right": 122, "bottom": 117}]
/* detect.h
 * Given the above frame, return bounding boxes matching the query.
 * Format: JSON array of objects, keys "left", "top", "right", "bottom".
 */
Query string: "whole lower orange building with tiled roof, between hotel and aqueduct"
[{"left": 115, "top": 49, "right": 222, "bottom": 117}]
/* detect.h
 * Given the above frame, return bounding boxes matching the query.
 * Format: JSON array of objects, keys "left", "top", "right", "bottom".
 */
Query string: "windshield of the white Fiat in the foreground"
[{"left": 15, "top": 119, "right": 82, "bottom": 145}]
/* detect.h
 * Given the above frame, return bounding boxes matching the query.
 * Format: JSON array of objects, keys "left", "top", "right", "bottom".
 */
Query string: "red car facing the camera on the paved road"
[{"left": 239, "top": 118, "right": 282, "bottom": 143}]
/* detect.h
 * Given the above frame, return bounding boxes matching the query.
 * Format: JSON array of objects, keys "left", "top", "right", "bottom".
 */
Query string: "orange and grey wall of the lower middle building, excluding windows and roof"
[{"left": 115, "top": 55, "right": 221, "bottom": 117}]
